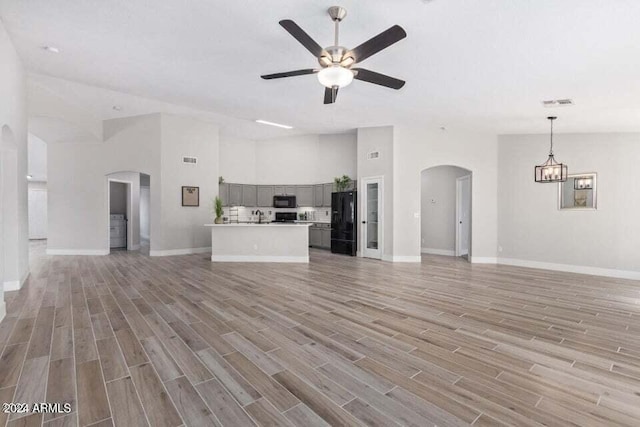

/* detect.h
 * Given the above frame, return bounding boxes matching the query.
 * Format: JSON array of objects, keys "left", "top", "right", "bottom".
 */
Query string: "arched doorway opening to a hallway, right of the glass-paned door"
[{"left": 420, "top": 165, "right": 473, "bottom": 260}]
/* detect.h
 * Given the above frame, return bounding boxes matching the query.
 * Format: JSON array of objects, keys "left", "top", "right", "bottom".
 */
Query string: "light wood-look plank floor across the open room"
[{"left": 0, "top": 244, "right": 640, "bottom": 426}]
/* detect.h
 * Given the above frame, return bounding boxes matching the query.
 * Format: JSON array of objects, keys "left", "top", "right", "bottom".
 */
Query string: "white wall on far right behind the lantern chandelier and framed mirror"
[{"left": 498, "top": 133, "right": 640, "bottom": 278}]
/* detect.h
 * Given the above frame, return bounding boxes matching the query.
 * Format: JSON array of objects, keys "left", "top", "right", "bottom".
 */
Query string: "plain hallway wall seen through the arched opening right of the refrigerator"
[{"left": 420, "top": 166, "right": 469, "bottom": 255}]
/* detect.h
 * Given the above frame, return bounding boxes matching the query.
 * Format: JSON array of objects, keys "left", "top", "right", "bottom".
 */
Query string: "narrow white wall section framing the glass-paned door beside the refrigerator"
[{"left": 357, "top": 126, "right": 395, "bottom": 261}]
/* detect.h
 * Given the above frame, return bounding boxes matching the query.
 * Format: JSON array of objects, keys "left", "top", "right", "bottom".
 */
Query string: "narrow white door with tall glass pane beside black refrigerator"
[{"left": 362, "top": 178, "right": 383, "bottom": 259}]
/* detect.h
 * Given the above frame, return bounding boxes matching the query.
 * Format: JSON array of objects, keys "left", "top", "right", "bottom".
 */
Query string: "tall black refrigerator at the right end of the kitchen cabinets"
[{"left": 331, "top": 191, "right": 358, "bottom": 256}]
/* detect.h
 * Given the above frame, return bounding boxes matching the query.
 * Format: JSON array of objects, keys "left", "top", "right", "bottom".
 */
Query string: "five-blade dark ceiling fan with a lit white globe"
[{"left": 260, "top": 6, "right": 407, "bottom": 104}]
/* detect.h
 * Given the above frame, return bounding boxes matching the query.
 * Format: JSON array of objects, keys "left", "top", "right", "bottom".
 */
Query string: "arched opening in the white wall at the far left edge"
[{"left": 0, "top": 125, "right": 19, "bottom": 291}]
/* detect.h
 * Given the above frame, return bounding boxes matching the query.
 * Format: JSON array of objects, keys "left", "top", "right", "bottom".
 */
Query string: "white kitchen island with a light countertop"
[{"left": 205, "top": 223, "right": 311, "bottom": 263}]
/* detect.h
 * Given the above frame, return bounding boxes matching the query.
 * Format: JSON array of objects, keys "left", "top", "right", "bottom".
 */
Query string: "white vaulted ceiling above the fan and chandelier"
[{"left": 0, "top": 0, "right": 640, "bottom": 139}]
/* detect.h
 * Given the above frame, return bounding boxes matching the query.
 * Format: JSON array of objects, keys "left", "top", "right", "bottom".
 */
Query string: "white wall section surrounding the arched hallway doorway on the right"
[{"left": 393, "top": 126, "right": 498, "bottom": 262}]
